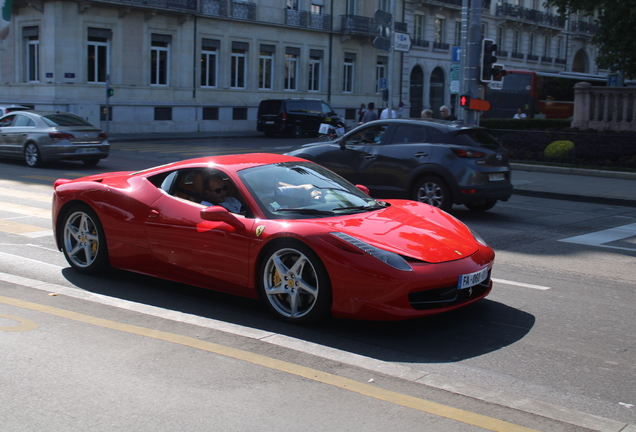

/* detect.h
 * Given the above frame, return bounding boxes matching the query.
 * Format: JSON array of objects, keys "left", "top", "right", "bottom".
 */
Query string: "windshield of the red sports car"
[{"left": 238, "top": 162, "right": 385, "bottom": 219}]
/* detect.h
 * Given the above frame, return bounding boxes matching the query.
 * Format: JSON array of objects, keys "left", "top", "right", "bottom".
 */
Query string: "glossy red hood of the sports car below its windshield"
[{"left": 314, "top": 200, "right": 479, "bottom": 263}]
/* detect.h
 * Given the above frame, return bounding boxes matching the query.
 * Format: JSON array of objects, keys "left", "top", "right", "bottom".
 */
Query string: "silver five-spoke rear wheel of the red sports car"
[{"left": 62, "top": 206, "right": 108, "bottom": 274}]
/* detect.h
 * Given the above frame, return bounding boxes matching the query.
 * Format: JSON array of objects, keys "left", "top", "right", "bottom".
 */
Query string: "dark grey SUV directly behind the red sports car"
[{"left": 287, "top": 119, "right": 512, "bottom": 211}]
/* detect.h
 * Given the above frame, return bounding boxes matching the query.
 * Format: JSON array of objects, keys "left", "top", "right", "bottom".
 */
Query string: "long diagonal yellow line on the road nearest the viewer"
[{"left": 0, "top": 296, "right": 537, "bottom": 432}]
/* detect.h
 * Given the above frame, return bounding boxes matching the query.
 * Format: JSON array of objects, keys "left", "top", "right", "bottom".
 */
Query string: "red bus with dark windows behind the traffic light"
[{"left": 483, "top": 71, "right": 607, "bottom": 118}]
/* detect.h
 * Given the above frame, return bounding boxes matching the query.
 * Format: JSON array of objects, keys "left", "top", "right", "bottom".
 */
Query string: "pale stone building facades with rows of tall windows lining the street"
[{"left": 0, "top": 0, "right": 596, "bottom": 133}]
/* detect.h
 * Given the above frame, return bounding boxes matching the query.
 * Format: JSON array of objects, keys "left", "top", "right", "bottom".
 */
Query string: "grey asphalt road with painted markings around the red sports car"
[{"left": 0, "top": 138, "right": 636, "bottom": 432}]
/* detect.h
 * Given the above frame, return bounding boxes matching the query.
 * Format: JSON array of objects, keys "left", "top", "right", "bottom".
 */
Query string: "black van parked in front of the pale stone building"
[{"left": 256, "top": 99, "right": 345, "bottom": 138}]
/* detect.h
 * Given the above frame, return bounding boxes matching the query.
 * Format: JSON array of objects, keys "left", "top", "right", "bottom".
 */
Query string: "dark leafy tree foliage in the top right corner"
[{"left": 546, "top": 0, "right": 636, "bottom": 78}]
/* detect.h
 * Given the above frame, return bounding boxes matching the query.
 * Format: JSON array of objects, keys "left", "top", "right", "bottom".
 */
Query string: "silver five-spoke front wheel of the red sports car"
[{"left": 259, "top": 242, "right": 331, "bottom": 323}]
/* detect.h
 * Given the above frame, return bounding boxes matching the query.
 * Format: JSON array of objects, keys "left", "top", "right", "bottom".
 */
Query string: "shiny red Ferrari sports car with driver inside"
[{"left": 53, "top": 154, "right": 495, "bottom": 322}]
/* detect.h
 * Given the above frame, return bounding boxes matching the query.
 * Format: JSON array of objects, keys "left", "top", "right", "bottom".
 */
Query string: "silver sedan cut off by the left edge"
[{"left": 0, "top": 110, "right": 110, "bottom": 167}]
